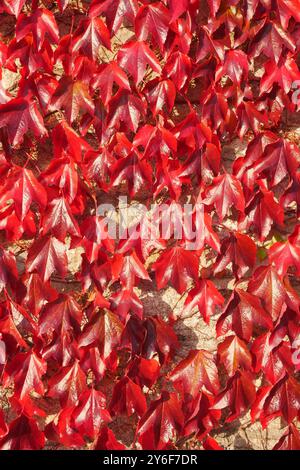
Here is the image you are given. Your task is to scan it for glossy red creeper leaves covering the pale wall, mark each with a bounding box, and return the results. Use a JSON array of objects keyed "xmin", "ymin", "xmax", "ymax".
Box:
[{"xmin": 0, "ymin": 0, "xmax": 300, "ymax": 449}]
